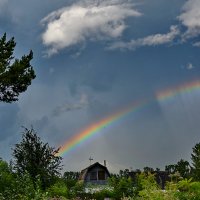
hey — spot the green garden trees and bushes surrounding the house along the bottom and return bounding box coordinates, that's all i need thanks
[0,128,200,200]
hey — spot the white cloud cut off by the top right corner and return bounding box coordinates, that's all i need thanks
[178,0,200,38]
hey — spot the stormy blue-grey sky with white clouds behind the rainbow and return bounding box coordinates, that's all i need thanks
[0,0,200,172]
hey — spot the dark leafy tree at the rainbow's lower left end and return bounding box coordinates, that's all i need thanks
[13,128,62,189]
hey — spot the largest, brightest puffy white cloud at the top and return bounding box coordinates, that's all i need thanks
[41,0,141,55]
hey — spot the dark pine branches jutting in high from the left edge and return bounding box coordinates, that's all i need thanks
[0,34,36,103]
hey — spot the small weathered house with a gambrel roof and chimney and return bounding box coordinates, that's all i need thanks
[79,161,110,185]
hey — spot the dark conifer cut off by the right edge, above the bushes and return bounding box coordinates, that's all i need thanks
[191,143,200,181]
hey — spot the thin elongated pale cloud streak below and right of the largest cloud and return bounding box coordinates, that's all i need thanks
[108,26,180,50]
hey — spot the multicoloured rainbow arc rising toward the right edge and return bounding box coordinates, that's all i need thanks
[57,80,200,156]
